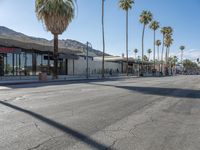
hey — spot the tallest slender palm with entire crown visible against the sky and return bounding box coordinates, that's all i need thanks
[140,10,152,74]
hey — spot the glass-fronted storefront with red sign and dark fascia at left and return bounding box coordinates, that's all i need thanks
[0,46,78,76]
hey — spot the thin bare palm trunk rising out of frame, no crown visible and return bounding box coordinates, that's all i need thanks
[102,0,105,78]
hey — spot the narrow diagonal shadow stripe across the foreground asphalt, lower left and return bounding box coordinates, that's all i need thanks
[0,101,111,150]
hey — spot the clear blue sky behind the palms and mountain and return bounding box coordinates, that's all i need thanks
[0,0,200,59]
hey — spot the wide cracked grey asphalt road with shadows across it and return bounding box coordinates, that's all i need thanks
[0,76,200,150]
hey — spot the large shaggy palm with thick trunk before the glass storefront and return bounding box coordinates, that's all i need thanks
[35,0,75,79]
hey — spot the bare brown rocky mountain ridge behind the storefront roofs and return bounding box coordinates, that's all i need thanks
[0,26,109,57]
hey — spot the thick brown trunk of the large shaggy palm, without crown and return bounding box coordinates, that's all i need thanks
[53,34,58,79]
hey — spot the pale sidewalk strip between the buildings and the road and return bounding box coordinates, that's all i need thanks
[0,75,136,86]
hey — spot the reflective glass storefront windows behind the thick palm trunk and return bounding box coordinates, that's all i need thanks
[0,50,68,76]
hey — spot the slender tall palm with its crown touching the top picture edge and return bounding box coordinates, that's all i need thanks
[119,0,134,76]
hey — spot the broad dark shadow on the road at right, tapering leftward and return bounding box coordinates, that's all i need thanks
[90,83,200,99]
